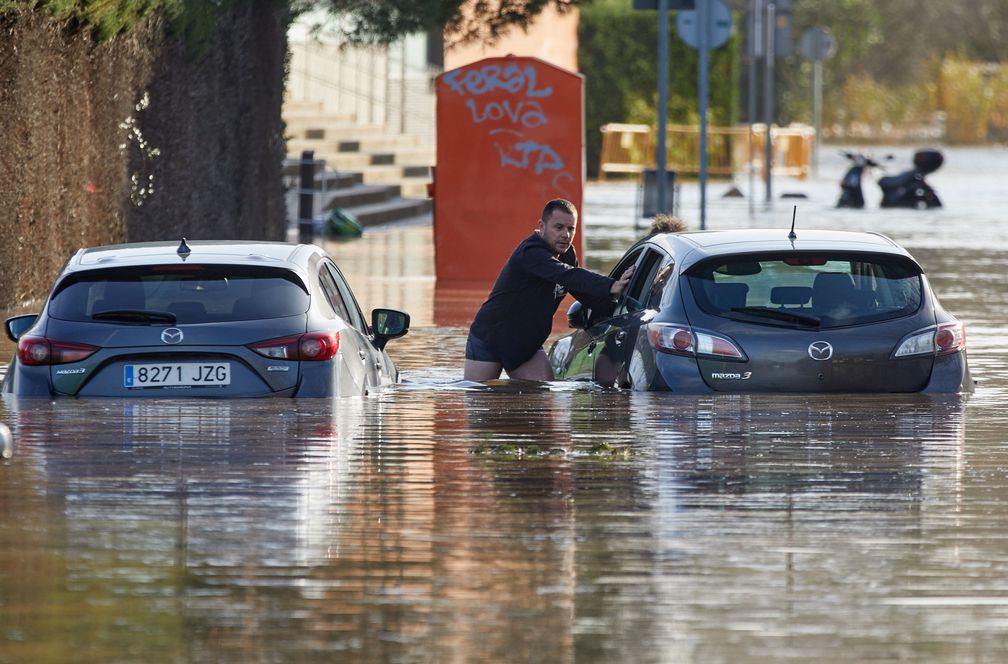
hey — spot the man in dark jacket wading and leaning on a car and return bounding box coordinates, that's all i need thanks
[464,198,633,382]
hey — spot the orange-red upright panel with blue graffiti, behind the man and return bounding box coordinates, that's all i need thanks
[433,56,585,283]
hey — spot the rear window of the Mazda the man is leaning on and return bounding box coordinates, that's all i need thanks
[688,252,922,328]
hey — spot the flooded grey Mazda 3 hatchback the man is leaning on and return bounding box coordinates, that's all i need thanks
[549,230,973,393]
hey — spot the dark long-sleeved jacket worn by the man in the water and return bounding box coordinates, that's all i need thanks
[469,233,613,371]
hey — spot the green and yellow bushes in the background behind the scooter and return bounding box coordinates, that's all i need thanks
[762,0,1008,143]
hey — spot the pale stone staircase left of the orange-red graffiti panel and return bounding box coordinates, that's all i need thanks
[283,102,434,226]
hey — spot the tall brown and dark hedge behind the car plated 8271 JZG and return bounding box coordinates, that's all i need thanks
[0,0,288,310]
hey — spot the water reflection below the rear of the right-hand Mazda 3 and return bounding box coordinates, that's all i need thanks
[628,395,966,511]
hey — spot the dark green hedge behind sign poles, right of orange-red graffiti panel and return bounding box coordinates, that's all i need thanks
[578,0,741,177]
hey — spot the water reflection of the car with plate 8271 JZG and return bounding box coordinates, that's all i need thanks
[0,395,385,575]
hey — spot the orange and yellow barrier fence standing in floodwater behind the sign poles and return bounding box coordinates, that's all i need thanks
[599,123,815,179]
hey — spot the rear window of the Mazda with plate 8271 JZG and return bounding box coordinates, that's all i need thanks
[48,265,308,324]
